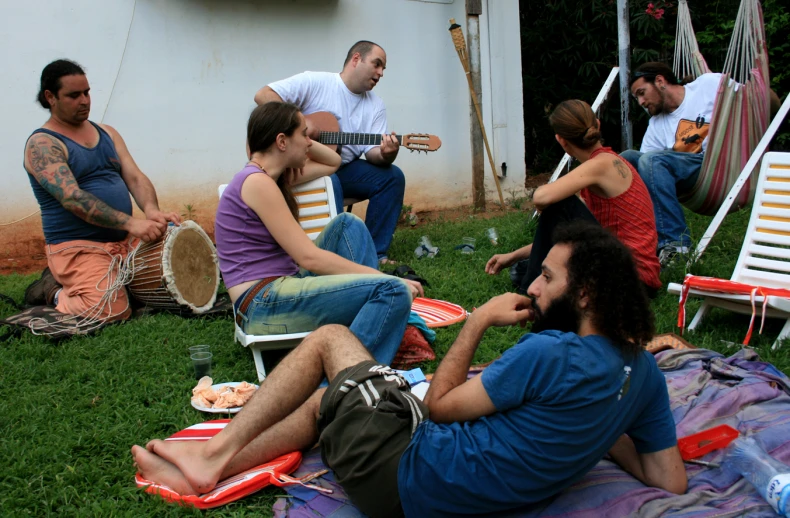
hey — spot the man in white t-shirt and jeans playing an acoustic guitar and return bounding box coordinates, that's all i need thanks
[255,40,406,263]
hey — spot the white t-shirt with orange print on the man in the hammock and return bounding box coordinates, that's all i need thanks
[640,74,721,153]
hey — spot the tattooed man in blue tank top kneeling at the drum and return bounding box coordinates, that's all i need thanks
[24,59,180,321]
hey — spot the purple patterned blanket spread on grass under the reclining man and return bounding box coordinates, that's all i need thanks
[274,349,790,518]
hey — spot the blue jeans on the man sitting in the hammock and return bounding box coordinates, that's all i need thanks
[620,149,704,250]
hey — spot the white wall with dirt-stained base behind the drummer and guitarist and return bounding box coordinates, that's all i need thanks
[0,0,524,260]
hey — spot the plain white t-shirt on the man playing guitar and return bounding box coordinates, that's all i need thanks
[268,71,387,164]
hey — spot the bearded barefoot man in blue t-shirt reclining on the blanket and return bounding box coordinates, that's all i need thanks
[132,223,686,517]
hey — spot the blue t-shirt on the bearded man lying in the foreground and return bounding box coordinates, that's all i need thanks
[398,331,677,517]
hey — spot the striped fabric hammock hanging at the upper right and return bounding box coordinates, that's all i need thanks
[674,0,770,215]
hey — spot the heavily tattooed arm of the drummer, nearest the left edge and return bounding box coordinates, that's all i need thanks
[25,133,162,241]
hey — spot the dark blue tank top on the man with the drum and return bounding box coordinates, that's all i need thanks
[27,122,132,245]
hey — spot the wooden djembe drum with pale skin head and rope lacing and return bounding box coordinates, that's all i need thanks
[129,221,220,313]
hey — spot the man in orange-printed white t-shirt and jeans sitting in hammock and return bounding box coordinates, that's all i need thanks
[621,62,721,267]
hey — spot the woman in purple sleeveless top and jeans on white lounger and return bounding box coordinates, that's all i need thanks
[215,102,422,370]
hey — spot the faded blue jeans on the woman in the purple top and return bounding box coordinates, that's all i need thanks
[239,213,411,365]
